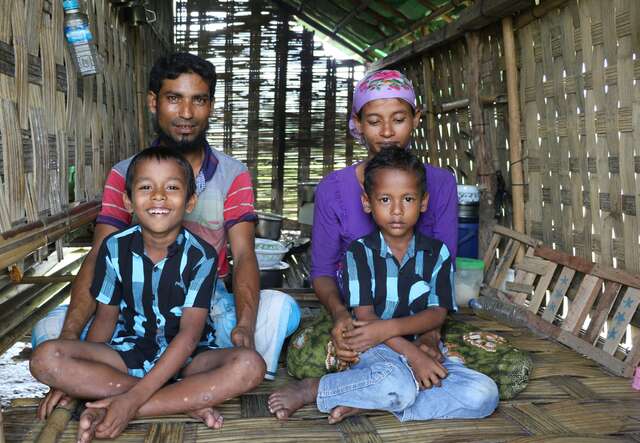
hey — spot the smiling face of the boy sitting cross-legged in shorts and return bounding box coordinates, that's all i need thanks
[124,159,196,235]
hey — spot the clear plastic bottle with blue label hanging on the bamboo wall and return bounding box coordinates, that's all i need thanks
[62,0,99,77]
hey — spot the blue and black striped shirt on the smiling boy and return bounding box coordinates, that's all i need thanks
[91,225,217,372]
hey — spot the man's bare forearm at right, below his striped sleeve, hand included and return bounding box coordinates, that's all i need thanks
[228,222,260,349]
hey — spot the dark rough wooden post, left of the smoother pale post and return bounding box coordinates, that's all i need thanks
[465,32,497,256]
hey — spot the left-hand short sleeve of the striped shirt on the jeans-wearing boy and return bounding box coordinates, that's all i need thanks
[341,241,375,308]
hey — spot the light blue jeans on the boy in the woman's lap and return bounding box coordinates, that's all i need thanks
[316,345,499,421]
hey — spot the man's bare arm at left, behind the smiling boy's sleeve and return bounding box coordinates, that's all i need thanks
[60,223,118,339]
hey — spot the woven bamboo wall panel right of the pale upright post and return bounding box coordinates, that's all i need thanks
[517,0,640,272]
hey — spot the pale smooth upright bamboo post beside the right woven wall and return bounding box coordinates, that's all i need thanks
[502,17,525,253]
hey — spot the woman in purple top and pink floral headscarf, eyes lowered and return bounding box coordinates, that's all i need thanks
[311,70,458,361]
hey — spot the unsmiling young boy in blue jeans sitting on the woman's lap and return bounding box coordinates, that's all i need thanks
[269,148,498,423]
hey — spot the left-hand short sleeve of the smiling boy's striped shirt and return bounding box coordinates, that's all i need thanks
[90,237,122,305]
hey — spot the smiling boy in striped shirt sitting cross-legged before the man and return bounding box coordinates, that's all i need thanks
[31,147,265,442]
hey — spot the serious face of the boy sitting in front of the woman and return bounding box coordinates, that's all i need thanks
[362,168,429,243]
